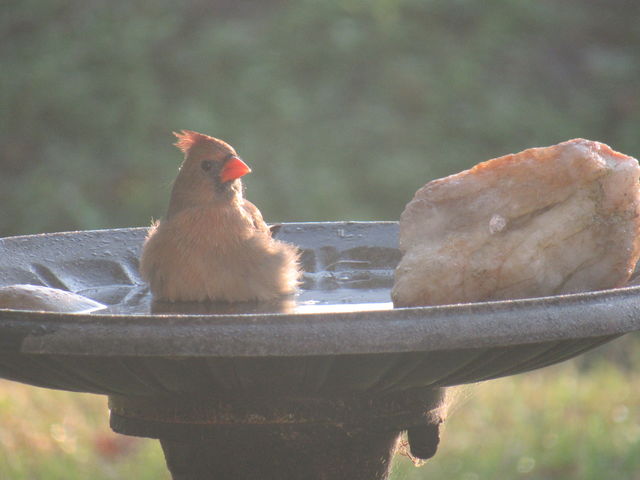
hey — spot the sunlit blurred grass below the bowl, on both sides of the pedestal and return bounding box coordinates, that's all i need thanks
[0,337,640,480]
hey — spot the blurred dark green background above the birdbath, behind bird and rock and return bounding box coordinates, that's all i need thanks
[0,0,640,235]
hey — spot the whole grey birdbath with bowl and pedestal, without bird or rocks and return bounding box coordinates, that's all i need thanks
[0,222,640,480]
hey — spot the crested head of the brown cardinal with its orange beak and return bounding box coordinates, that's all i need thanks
[168,130,251,216]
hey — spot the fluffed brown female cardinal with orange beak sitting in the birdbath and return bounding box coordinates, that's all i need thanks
[140,130,300,302]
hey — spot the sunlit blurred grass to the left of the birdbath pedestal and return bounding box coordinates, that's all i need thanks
[0,380,169,480]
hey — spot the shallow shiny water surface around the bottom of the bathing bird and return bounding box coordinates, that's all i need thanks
[81,285,393,315]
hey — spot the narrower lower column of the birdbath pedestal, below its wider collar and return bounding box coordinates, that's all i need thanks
[160,427,400,480]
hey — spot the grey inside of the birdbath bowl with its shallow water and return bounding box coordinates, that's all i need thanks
[0,222,400,315]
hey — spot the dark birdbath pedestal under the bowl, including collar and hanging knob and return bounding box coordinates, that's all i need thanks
[109,389,443,480]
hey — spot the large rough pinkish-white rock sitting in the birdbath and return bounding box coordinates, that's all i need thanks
[392,139,640,307]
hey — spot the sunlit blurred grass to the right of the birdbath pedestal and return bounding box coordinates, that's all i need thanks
[392,339,640,480]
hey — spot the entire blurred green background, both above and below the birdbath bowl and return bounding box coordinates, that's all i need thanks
[0,0,640,480]
